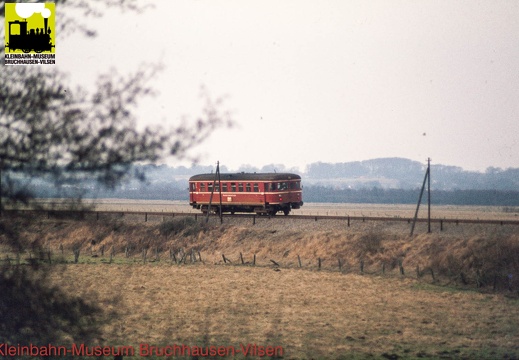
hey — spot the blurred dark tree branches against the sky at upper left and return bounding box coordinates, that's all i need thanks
[0,0,230,210]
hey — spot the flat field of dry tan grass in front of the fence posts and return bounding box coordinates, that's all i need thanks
[46,264,519,358]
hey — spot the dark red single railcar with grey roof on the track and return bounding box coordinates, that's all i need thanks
[189,173,303,215]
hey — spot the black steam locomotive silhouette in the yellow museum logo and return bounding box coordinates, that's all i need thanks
[6,18,54,53]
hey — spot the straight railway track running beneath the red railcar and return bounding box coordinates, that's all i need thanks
[2,209,519,225]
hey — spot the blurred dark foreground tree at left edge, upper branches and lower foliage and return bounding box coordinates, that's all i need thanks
[0,0,230,350]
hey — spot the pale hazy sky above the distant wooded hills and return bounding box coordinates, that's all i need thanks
[56,0,519,171]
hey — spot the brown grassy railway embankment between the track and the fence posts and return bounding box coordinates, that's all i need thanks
[0,217,519,294]
